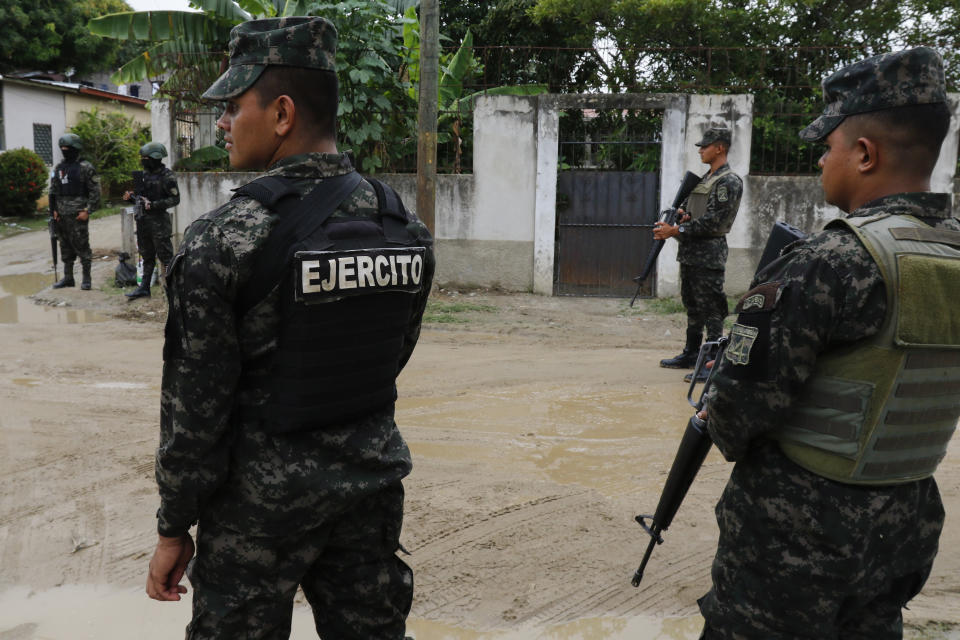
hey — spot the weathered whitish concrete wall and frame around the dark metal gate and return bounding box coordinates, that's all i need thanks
[163,94,960,296]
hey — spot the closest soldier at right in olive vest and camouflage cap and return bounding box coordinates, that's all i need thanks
[700,48,960,640]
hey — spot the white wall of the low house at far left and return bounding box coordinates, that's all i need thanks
[3,82,67,165]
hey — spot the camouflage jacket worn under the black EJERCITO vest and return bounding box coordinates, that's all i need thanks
[156,153,433,536]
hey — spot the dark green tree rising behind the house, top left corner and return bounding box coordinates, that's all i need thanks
[0,0,138,75]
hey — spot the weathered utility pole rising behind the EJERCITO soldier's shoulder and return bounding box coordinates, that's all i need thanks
[417,0,440,235]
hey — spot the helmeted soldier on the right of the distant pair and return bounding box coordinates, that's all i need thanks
[123,142,180,300]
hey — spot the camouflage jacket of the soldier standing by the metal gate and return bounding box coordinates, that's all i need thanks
[677,164,743,269]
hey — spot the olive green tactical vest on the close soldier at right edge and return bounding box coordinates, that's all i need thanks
[776,214,960,485]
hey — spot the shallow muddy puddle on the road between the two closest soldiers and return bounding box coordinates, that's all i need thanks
[397,386,692,494]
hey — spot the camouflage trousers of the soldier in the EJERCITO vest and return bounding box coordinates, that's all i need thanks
[186,482,413,640]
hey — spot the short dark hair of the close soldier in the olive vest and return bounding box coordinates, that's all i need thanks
[846,102,950,176]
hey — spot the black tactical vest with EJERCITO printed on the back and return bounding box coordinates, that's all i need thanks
[237,173,430,433]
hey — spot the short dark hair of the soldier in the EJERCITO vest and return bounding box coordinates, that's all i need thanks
[251,65,340,140]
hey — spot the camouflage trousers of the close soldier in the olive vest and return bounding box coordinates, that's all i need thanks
[699,441,944,640]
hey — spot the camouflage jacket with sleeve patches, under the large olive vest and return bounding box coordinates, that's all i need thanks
[707,193,960,460]
